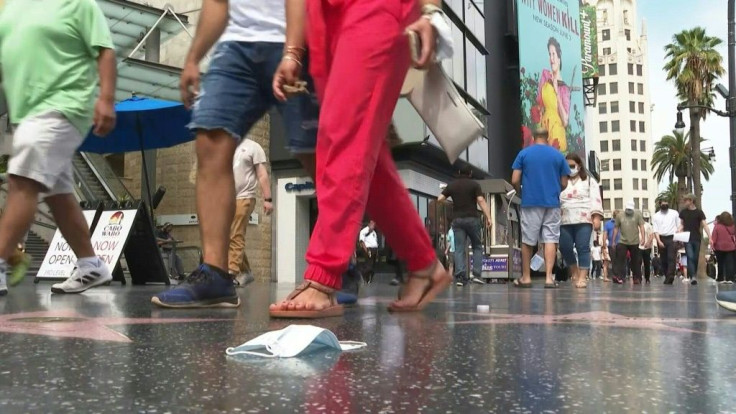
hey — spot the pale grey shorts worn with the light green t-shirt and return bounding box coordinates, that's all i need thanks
[8,111,84,197]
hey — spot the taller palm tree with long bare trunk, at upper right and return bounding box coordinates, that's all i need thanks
[664,27,725,205]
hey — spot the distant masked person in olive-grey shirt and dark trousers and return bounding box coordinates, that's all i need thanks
[613,201,644,285]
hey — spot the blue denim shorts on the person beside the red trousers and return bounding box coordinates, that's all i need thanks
[189,41,319,153]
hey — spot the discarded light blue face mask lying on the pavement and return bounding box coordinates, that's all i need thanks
[225,325,367,358]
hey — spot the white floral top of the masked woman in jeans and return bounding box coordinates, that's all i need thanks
[560,176,603,225]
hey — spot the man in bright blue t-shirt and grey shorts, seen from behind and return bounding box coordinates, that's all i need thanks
[511,130,571,288]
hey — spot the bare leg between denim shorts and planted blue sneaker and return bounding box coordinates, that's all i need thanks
[196,130,238,269]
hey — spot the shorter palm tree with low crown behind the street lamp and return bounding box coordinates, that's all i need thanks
[652,130,714,206]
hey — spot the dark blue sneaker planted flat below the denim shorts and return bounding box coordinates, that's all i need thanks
[151,264,240,308]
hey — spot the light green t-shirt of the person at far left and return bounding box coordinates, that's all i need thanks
[0,0,113,135]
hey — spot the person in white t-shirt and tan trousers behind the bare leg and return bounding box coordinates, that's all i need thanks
[227,138,273,287]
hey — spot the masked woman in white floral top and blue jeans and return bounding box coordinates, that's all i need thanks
[560,153,603,288]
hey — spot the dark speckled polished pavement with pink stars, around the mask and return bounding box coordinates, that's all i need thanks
[0,279,736,414]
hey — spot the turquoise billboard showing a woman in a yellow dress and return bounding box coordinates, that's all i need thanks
[517,0,586,159]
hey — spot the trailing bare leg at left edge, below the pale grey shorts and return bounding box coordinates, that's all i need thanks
[0,175,42,260]
